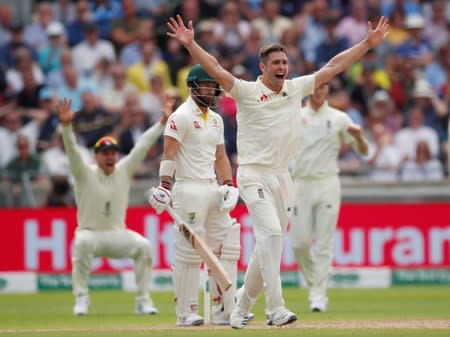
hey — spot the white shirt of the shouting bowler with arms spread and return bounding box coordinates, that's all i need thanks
[229,75,315,169]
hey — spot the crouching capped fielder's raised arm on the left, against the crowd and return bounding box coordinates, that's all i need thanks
[56,98,85,177]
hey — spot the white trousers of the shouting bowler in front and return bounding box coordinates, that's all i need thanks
[237,166,293,315]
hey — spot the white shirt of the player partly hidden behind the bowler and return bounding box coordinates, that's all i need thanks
[292,102,357,179]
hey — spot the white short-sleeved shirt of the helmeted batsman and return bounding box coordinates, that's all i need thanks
[164,97,224,181]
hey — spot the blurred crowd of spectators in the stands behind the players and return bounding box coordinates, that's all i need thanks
[0,0,450,206]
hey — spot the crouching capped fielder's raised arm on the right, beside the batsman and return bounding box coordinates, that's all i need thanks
[120,95,175,176]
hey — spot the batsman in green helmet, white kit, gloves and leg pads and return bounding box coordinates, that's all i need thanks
[149,65,240,326]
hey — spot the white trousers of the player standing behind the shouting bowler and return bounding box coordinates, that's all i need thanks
[290,176,341,301]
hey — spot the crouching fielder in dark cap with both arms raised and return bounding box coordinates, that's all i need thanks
[58,97,174,316]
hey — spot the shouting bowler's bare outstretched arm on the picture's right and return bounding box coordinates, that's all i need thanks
[315,16,389,88]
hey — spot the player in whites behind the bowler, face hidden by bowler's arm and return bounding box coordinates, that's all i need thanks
[290,84,368,312]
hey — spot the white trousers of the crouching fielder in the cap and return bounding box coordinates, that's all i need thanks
[72,229,152,302]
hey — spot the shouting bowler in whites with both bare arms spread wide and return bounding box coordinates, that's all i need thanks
[167,15,388,329]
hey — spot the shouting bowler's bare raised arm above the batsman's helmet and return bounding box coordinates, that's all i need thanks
[167,15,235,92]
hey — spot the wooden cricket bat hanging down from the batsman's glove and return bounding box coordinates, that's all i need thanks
[166,206,231,291]
